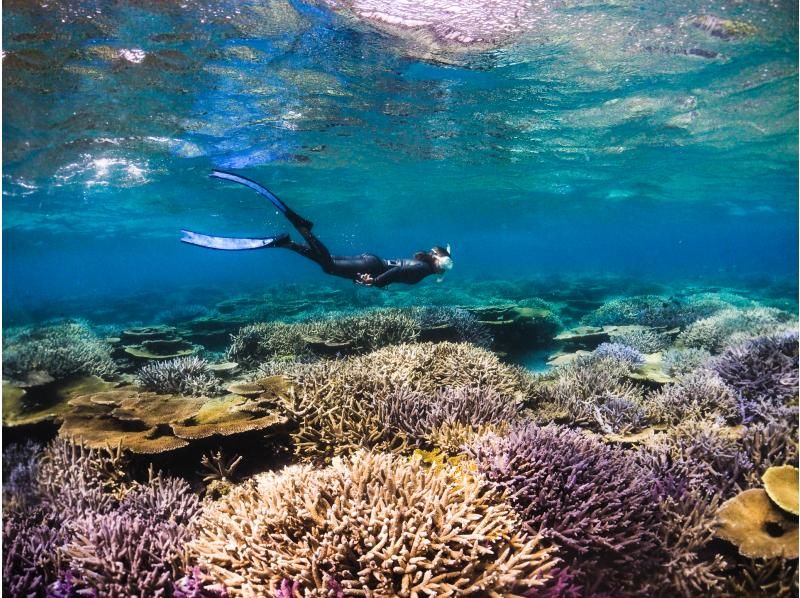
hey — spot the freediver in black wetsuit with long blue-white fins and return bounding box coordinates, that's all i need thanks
[181,170,453,288]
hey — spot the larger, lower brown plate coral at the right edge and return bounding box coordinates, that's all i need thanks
[717,488,798,559]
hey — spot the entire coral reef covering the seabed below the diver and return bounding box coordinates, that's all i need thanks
[3,282,798,598]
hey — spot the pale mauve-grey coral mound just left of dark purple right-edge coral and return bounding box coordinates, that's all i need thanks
[645,368,741,424]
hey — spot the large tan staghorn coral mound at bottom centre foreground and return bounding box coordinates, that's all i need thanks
[190,451,555,596]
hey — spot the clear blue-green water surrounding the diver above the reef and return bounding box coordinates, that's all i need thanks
[3,0,798,328]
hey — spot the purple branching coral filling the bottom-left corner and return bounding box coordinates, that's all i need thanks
[3,440,200,596]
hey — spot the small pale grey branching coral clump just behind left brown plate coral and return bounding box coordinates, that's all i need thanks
[136,357,223,397]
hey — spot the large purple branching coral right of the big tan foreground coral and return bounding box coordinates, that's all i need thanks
[469,424,664,595]
